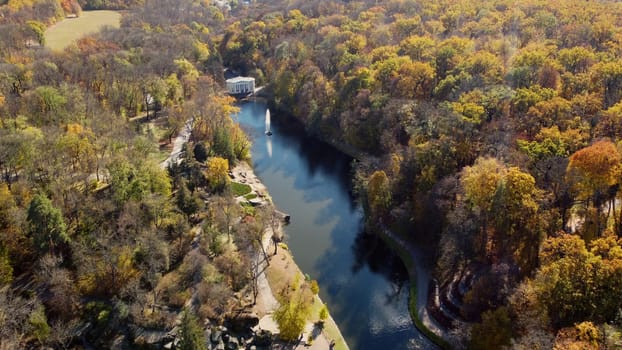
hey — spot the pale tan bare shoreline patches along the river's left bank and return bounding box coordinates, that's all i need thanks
[231,161,350,350]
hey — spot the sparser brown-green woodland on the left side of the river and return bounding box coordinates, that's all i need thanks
[0,0,292,349]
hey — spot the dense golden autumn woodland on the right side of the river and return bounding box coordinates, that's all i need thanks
[219,0,622,349]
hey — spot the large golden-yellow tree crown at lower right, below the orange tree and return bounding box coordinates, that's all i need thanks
[533,234,622,327]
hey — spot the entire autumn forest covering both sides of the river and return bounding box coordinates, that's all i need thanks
[0,0,622,349]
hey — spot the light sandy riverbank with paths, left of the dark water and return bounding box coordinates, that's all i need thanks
[231,162,349,350]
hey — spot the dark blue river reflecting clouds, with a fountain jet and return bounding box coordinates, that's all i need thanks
[234,102,435,350]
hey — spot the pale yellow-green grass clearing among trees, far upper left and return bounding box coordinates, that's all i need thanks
[45,11,121,51]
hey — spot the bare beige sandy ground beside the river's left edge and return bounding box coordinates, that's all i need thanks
[231,162,344,350]
